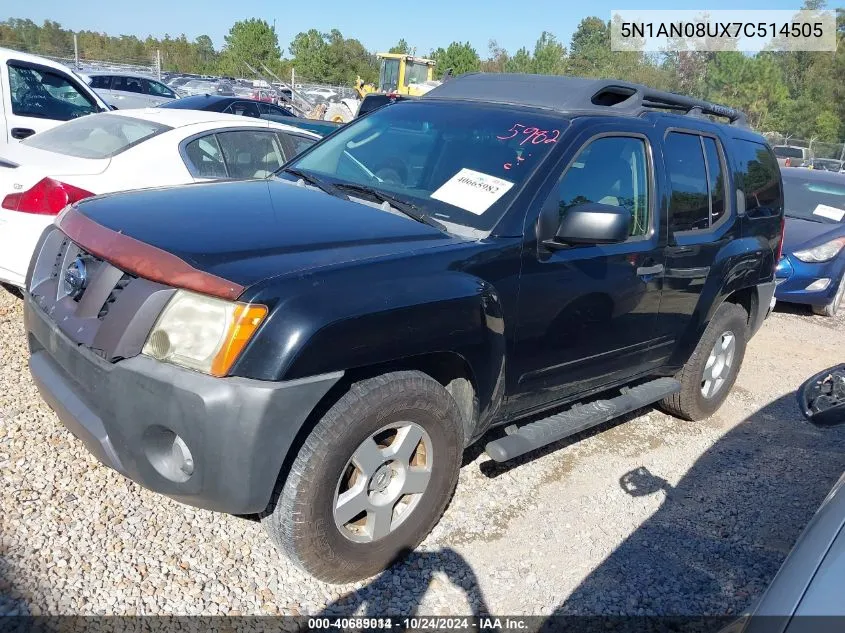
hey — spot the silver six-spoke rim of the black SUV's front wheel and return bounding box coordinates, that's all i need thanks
[332,422,434,543]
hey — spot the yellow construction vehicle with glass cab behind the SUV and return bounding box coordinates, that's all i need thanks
[323,53,440,123]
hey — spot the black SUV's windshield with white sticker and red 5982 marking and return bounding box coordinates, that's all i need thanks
[290,100,569,231]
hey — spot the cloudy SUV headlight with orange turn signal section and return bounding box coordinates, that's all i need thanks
[141,290,267,376]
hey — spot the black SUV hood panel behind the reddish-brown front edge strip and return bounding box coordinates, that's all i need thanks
[77,180,457,286]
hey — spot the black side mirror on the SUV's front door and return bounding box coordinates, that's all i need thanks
[547,202,631,244]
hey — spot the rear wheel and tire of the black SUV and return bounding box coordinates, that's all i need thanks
[659,302,748,420]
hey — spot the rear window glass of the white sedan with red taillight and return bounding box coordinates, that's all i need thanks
[21,114,172,158]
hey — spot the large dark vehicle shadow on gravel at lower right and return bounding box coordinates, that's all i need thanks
[547,393,845,629]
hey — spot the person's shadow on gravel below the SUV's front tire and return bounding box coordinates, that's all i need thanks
[318,547,489,631]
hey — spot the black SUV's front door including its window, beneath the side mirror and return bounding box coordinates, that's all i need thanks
[508,122,665,412]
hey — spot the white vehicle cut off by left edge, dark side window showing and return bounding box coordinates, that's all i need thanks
[0,48,109,148]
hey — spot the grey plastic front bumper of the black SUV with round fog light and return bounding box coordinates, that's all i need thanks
[24,297,343,514]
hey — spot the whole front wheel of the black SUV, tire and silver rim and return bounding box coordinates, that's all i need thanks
[262,371,463,583]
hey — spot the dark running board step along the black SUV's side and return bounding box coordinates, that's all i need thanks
[485,378,681,462]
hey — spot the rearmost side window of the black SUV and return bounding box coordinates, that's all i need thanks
[734,139,783,215]
